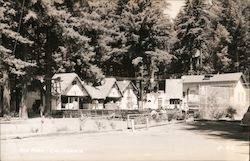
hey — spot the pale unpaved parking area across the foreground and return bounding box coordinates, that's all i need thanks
[1,123,249,161]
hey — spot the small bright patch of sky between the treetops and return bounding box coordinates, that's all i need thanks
[165,0,185,19]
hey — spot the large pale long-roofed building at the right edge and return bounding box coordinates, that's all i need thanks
[181,73,249,117]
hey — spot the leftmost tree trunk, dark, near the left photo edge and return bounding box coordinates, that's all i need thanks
[3,70,10,116]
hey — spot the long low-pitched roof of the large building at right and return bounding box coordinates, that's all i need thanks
[181,73,243,83]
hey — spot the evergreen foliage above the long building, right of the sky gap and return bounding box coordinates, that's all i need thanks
[170,0,250,75]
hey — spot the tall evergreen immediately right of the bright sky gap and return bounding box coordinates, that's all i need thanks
[173,0,217,74]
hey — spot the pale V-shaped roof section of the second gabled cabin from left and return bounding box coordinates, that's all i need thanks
[83,78,119,99]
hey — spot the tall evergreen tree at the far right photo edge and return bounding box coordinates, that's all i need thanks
[220,0,250,80]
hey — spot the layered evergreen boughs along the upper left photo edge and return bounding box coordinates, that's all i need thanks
[0,1,35,76]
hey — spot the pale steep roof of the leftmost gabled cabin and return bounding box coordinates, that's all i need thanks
[52,73,81,93]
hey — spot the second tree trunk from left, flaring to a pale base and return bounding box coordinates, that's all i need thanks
[19,83,28,119]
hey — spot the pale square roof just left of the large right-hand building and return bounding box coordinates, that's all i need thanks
[165,79,183,99]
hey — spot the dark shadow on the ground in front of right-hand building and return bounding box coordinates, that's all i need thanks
[184,120,250,141]
